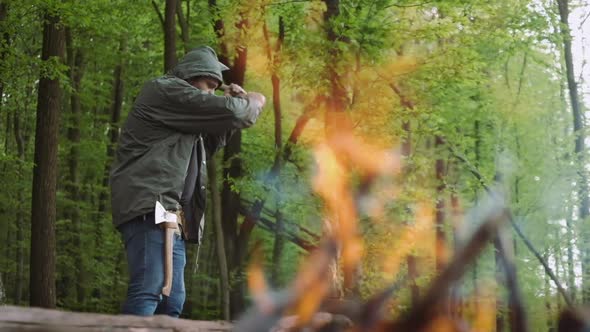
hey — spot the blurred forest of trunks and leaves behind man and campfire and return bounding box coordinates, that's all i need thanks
[0,0,590,331]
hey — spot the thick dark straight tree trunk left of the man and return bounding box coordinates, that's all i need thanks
[30,14,64,308]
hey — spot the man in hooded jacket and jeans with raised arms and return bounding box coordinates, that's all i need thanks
[110,46,266,317]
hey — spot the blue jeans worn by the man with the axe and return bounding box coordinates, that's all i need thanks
[118,213,186,317]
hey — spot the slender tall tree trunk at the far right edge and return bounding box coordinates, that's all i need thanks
[557,0,590,304]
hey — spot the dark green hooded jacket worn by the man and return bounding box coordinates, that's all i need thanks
[110,47,261,242]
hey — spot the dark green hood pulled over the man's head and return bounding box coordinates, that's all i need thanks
[171,46,229,85]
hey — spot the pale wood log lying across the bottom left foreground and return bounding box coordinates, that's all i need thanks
[0,306,232,332]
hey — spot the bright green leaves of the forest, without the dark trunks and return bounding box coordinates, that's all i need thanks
[0,0,583,331]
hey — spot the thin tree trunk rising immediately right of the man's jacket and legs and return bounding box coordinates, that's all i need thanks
[207,158,230,321]
